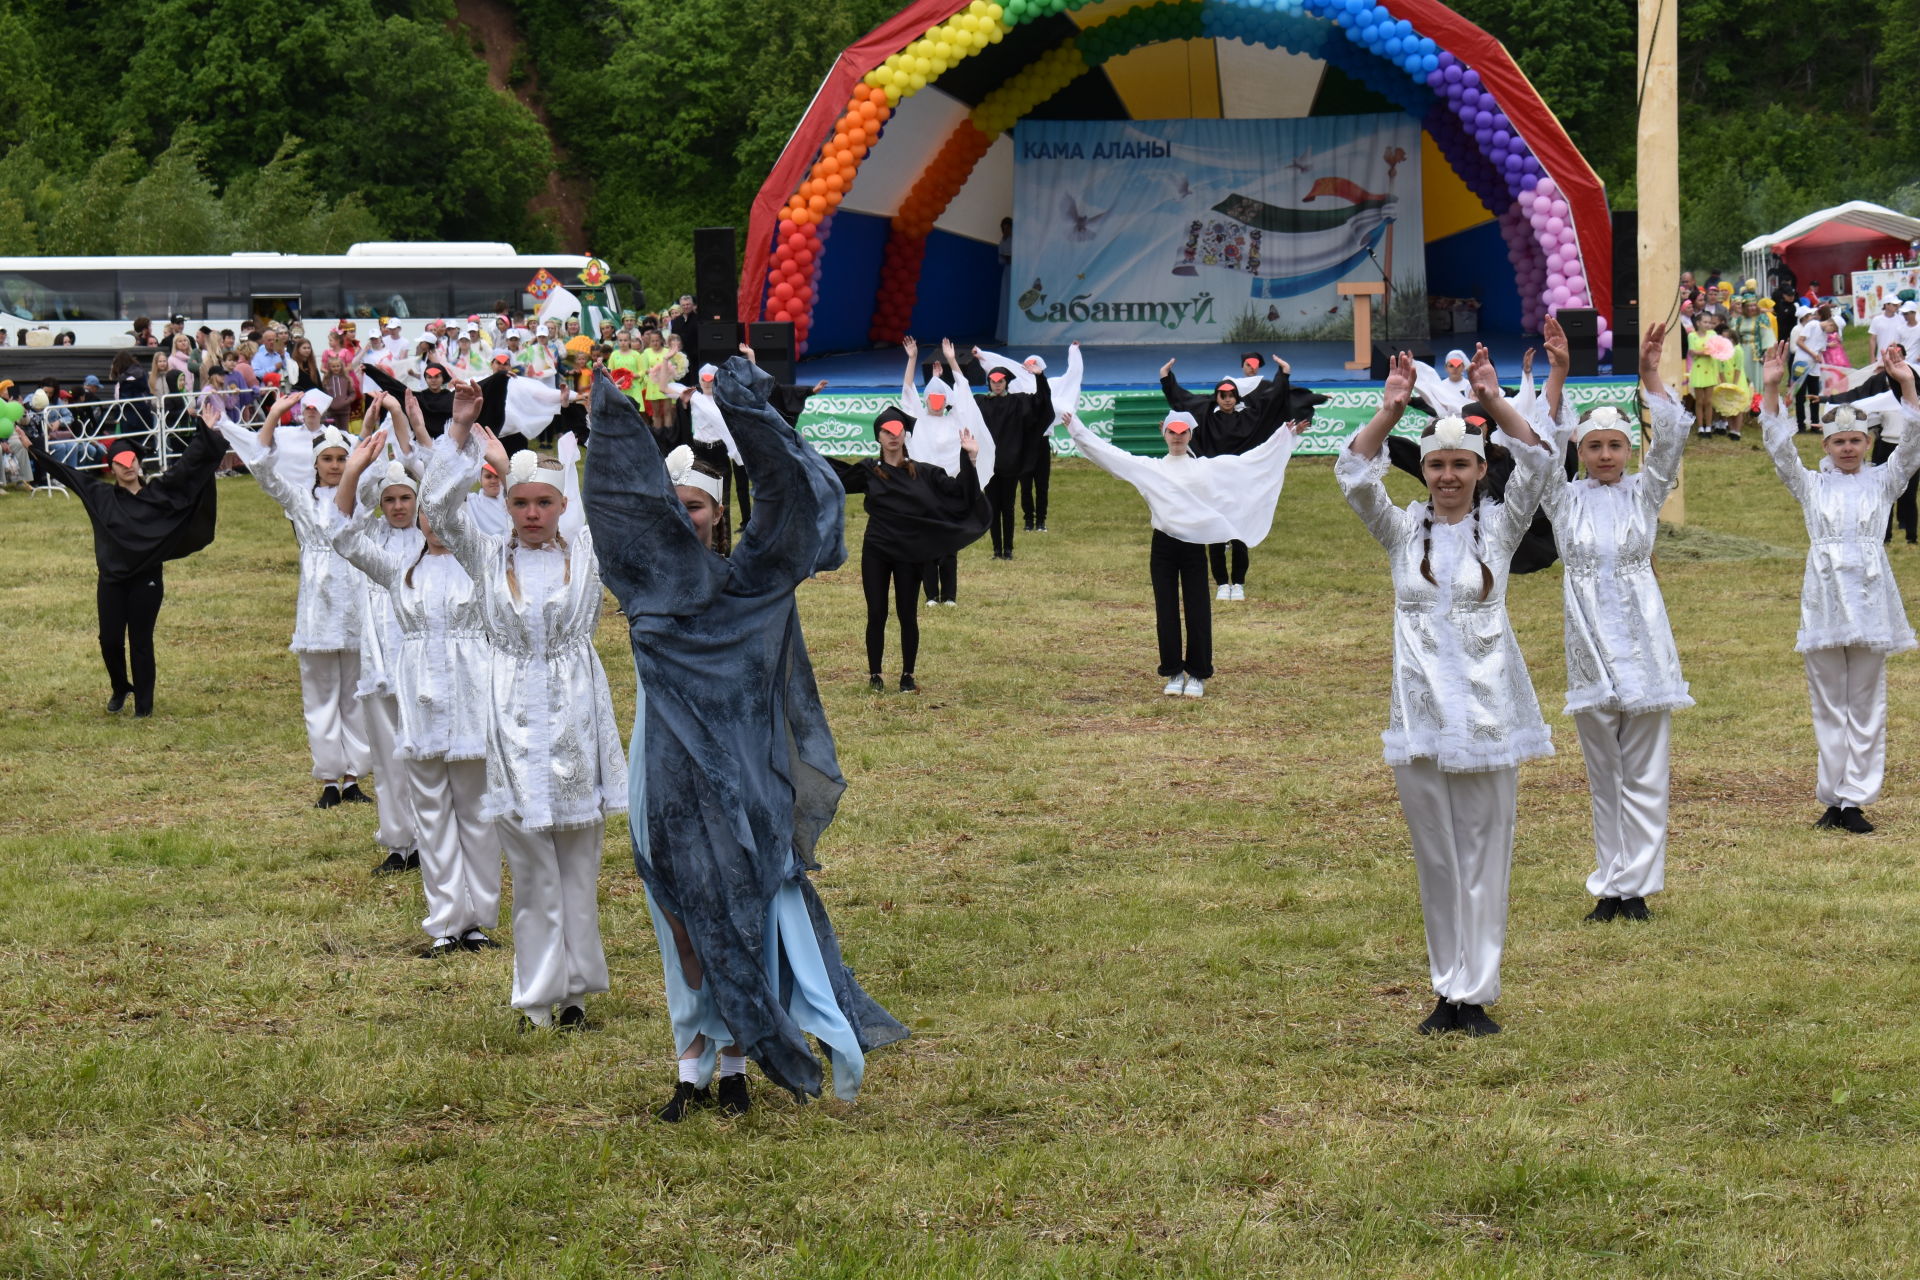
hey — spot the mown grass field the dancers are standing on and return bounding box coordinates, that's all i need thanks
[0,432,1920,1278]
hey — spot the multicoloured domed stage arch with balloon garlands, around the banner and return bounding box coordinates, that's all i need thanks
[739,0,1613,351]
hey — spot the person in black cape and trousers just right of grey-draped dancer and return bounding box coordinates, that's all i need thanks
[833,407,991,693]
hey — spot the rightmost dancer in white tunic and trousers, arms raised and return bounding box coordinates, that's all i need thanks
[1761,344,1920,835]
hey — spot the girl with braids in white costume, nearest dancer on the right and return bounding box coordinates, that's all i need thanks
[1334,347,1555,1036]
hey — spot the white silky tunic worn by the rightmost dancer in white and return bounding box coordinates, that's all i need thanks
[1761,407,1920,652]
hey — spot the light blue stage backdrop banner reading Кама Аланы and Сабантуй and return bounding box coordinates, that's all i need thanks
[1010,113,1427,345]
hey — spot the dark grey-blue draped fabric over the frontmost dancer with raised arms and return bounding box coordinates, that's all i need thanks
[584,357,906,1096]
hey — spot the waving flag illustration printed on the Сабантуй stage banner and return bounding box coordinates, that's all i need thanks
[1173,178,1398,297]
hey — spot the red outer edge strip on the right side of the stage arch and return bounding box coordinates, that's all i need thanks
[1379,0,1613,328]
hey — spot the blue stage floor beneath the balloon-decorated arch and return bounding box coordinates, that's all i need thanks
[797,334,1605,391]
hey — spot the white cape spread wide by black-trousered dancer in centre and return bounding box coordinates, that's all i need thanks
[1068,418,1300,547]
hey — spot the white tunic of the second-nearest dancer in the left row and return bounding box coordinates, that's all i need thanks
[334,510,492,760]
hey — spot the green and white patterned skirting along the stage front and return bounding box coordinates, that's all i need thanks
[801,378,1640,459]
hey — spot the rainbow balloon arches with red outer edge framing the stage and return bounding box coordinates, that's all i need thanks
[739,0,1613,362]
